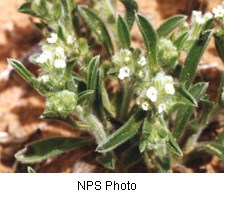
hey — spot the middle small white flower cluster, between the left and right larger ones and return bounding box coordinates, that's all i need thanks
[112,49,147,80]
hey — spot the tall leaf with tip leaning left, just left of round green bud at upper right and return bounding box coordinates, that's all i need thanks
[136,14,158,72]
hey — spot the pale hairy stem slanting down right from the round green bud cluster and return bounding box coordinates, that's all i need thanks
[75,106,107,144]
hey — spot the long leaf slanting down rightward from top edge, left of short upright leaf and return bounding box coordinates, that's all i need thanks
[78,6,113,55]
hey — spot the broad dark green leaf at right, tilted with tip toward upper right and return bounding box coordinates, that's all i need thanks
[180,31,212,88]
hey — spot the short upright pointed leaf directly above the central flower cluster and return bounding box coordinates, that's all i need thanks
[117,15,131,49]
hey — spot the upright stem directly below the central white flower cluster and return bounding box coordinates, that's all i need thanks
[118,83,133,121]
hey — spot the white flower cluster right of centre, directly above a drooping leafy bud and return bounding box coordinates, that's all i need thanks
[137,72,175,114]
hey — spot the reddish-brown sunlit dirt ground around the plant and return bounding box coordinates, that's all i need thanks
[0,0,223,172]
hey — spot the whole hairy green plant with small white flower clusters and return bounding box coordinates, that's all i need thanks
[9,0,224,172]
